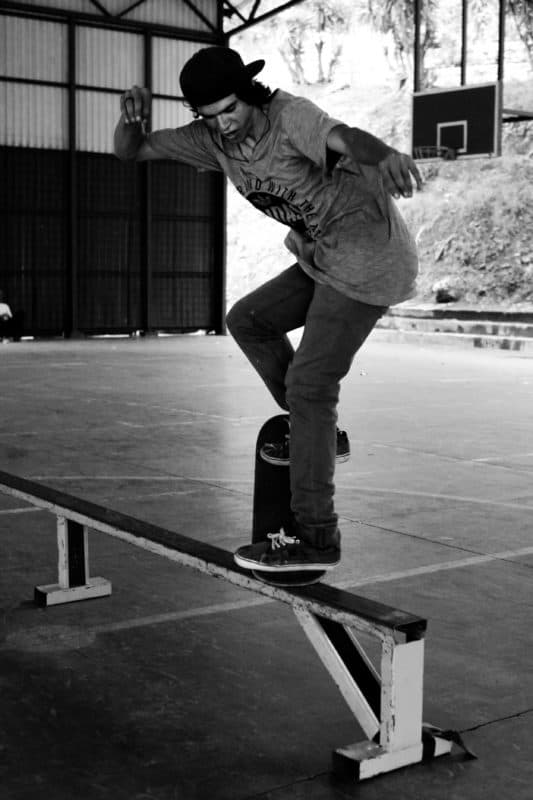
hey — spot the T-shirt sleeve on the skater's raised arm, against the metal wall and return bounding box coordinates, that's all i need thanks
[147,120,222,171]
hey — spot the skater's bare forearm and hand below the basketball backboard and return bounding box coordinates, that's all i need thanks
[327,125,422,198]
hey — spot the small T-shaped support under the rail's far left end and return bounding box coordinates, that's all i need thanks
[34,516,111,606]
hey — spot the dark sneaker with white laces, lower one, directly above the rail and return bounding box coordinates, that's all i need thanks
[234,531,341,572]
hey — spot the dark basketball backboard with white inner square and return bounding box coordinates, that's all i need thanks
[412,82,502,160]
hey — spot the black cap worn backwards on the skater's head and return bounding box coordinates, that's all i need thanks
[180,47,265,108]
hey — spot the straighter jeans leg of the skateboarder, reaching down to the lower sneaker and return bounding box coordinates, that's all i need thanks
[286,284,386,547]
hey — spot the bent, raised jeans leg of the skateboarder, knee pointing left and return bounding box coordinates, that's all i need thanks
[226,264,315,411]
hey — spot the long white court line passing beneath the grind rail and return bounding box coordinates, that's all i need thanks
[84,547,533,633]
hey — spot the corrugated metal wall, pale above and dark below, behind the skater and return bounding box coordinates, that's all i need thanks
[0,0,224,335]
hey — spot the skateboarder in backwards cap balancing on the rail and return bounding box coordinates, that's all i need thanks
[115,47,421,573]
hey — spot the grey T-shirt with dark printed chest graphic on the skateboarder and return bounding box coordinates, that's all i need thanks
[148,90,418,306]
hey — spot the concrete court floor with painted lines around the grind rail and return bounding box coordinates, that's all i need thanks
[0,336,533,800]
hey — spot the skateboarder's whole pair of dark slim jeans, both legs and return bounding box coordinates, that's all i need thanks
[227,264,387,548]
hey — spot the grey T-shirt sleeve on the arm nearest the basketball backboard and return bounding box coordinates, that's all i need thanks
[282,97,341,169]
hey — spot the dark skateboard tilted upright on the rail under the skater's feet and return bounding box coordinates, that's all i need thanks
[252,414,326,587]
